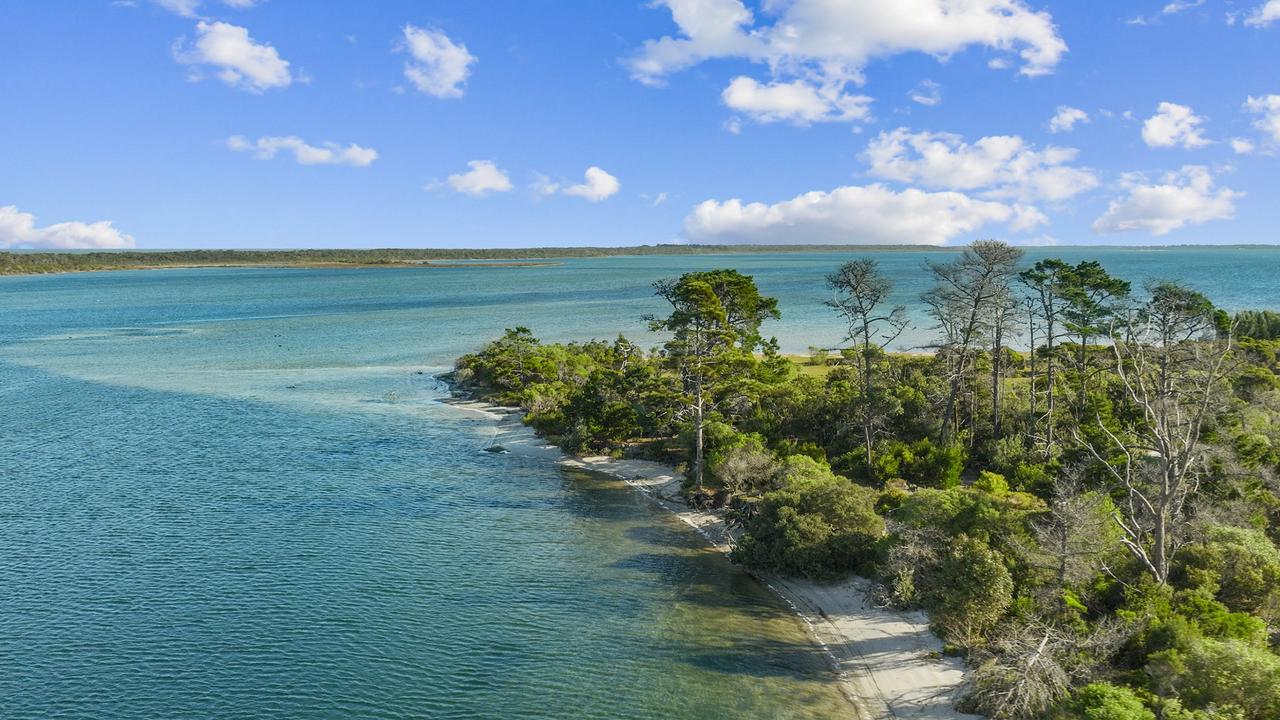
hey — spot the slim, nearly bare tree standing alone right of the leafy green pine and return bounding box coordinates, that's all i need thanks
[827,258,909,480]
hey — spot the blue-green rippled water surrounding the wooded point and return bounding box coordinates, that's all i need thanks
[0,249,1280,719]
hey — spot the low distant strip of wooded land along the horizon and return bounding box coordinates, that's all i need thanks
[0,245,947,275]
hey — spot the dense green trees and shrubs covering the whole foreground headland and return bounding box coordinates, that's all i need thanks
[454,241,1280,720]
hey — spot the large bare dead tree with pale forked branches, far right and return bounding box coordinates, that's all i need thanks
[1076,283,1231,584]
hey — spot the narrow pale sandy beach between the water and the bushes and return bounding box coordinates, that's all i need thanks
[440,397,979,720]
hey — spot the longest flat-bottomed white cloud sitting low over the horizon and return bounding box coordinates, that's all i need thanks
[685,184,1046,245]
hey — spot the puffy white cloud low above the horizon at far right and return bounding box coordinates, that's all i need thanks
[1093,165,1244,237]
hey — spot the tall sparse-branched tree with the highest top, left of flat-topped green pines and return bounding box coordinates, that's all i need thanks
[923,240,1023,441]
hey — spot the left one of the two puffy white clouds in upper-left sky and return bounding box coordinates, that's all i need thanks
[174,20,293,92]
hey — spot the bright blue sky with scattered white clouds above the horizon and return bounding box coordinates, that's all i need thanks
[0,0,1280,250]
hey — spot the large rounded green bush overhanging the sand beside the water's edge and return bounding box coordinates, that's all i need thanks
[733,456,884,579]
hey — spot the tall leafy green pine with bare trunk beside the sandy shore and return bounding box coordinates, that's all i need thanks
[648,270,780,491]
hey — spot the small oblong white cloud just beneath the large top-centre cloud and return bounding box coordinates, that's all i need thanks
[721,76,872,126]
